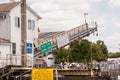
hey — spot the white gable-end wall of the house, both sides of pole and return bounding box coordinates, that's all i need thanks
[10,5,38,54]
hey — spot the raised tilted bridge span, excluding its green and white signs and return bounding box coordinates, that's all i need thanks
[34,22,97,59]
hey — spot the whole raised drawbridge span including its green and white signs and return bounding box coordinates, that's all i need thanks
[34,22,97,59]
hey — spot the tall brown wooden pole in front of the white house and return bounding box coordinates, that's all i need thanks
[21,0,27,66]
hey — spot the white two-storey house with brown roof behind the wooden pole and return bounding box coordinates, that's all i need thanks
[0,1,41,67]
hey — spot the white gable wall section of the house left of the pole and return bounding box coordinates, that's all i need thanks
[10,5,21,54]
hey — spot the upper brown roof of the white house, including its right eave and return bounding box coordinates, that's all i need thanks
[0,2,41,19]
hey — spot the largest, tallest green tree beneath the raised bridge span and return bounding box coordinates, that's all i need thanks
[70,39,90,63]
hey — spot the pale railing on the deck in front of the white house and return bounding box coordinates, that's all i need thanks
[0,54,33,68]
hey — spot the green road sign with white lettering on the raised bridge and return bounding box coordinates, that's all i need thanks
[40,41,52,54]
